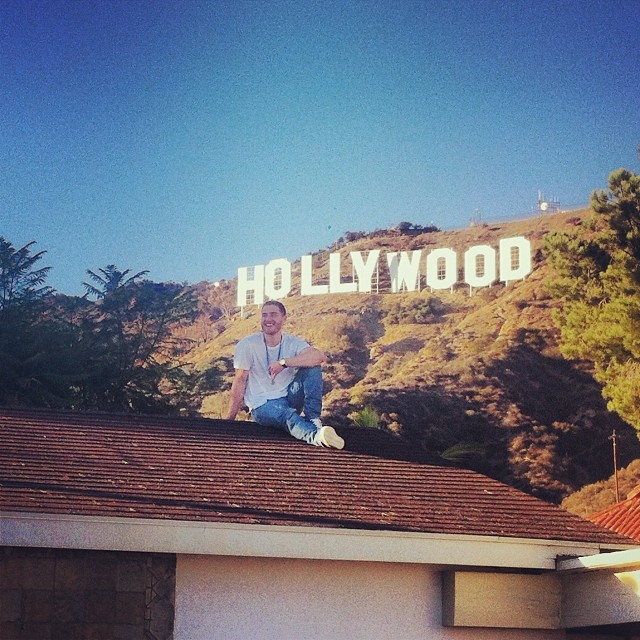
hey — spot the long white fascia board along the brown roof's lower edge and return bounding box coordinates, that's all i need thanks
[0,511,628,570]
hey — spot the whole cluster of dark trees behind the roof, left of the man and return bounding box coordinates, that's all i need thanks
[0,237,220,413]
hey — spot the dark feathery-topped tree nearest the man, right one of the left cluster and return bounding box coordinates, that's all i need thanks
[78,265,208,411]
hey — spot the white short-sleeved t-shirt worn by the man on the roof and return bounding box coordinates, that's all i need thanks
[233,332,310,410]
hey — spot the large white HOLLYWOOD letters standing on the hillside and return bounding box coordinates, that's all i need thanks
[237,236,531,307]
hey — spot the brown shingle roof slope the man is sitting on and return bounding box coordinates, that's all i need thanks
[0,410,629,545]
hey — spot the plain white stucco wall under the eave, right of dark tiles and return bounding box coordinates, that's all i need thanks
[175,555,565,640]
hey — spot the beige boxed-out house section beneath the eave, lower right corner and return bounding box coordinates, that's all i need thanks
[442,548,640,637]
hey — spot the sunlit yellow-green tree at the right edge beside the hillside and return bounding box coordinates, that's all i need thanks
[545,169,640,431]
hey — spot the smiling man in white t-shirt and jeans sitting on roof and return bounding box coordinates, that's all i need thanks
[227,300,344,449]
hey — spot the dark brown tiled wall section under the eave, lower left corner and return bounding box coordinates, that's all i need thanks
[0,547,176,640]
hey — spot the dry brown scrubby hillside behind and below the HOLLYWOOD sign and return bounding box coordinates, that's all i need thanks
[184,210,640,502]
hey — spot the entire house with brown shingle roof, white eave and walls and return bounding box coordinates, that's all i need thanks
[0,409,640,640]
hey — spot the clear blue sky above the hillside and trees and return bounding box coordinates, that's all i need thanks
[0,0,640,293]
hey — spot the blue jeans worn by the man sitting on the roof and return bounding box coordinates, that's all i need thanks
[251,366,322,444]
